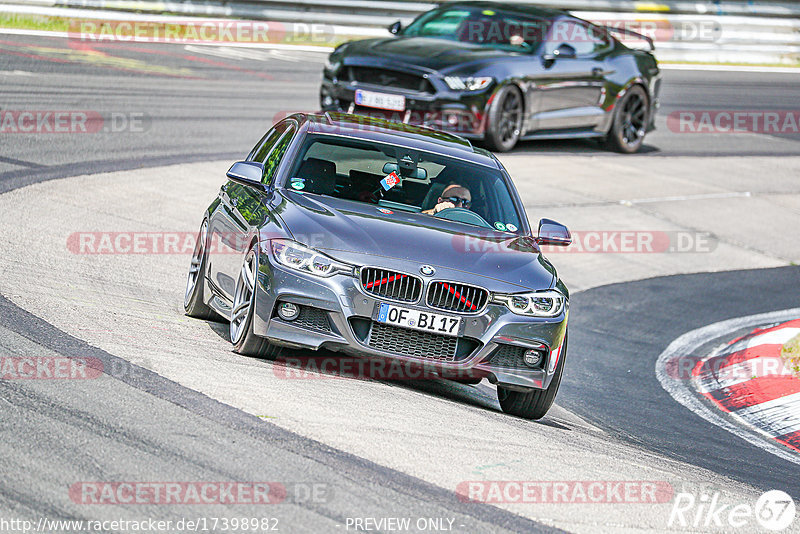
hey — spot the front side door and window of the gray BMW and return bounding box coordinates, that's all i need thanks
[208,122,297,304]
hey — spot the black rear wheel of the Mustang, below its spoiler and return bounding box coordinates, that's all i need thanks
[602,85,650,154]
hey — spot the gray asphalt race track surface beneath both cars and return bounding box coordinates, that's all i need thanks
[0,33,800,533]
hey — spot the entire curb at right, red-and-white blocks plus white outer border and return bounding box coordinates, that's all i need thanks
[655,308,800,464]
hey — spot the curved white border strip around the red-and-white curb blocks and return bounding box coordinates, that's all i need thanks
[656,308,800,465]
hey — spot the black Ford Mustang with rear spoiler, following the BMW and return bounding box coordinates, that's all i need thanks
[320,2,660,153]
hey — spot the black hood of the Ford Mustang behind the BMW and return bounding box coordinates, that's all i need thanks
[344,37,511,71]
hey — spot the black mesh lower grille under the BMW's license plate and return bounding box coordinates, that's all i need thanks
[366,321,479,362]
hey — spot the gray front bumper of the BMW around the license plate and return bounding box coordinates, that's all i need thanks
[253,252,568,390]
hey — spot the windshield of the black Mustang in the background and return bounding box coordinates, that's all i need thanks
[402,6,548,51]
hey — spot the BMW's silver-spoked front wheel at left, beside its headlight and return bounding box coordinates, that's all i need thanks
[230,244,282,360]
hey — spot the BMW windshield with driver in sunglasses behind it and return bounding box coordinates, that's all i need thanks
[285,134,522,232]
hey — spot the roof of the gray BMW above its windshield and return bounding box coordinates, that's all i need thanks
[298,112,499,168]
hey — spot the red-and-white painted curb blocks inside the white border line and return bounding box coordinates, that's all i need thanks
[692,319,800,451]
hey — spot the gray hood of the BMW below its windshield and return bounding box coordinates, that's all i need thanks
[275,190,555,289]
